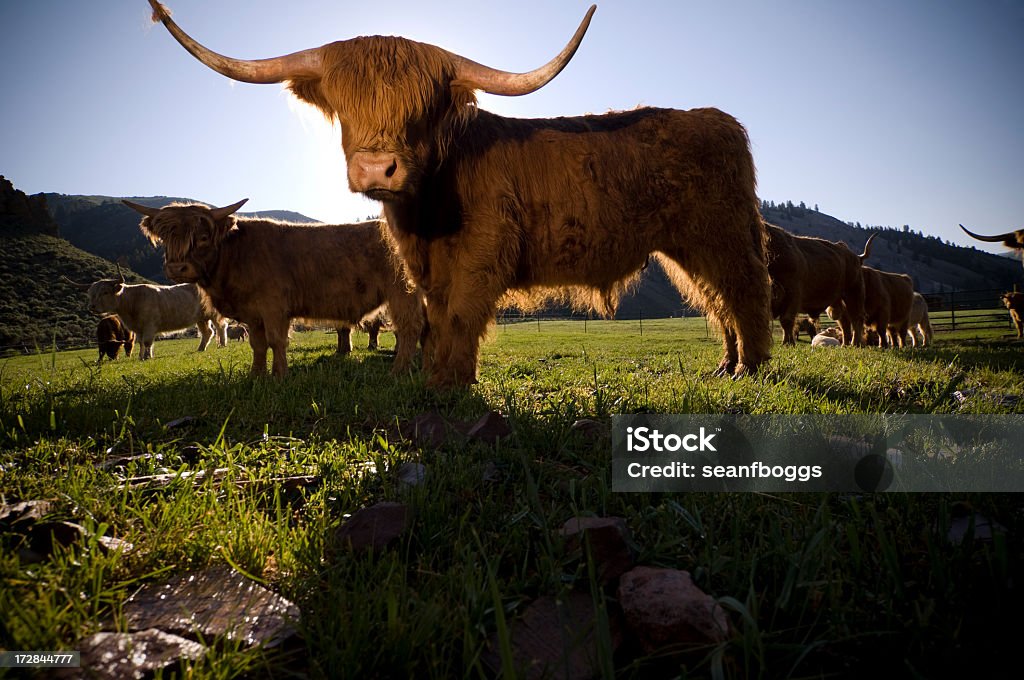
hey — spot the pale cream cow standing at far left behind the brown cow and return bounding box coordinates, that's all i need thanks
[68,267,227,360]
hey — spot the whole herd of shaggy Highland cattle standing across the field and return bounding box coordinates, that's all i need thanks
[66,0,1024,387]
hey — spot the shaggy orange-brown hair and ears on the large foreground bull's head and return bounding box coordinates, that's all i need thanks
[288,36,477,161]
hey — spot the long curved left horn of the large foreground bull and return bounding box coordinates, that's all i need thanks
[150,0,323,85]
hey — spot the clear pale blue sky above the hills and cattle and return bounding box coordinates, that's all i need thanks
[0,0,1024,252]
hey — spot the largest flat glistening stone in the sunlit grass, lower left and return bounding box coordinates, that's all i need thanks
[124,566,299,647]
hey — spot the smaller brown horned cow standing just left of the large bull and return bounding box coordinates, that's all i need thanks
[129,201,424,377]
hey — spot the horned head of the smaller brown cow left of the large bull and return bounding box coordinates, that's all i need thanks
[124,199,248,286]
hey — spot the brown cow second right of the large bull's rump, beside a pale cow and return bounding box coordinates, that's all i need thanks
[828,266,913,347]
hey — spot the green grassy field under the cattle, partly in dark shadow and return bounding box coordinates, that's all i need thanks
[0,318,1024,678]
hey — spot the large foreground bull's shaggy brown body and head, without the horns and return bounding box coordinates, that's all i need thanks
[154,2,771,386]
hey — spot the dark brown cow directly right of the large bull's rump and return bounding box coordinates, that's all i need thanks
[768,224,873,345]
